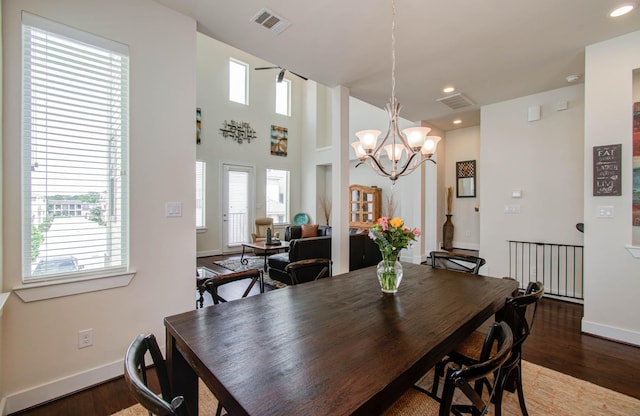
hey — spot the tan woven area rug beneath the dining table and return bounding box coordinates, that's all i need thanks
[114,361,640,416]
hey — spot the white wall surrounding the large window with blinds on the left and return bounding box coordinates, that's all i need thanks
[1,0,196,412]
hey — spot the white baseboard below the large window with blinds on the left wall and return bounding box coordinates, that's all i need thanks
[0,359,124,415]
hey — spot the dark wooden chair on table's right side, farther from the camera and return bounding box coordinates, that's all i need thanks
[432,282,544,416]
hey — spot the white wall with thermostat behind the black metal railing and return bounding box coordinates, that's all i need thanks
[478,84,584,277]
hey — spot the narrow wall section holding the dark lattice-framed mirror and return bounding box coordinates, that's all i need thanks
[440,126,482,250]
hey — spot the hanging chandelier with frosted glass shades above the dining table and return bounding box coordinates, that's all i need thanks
[351,0,441,183]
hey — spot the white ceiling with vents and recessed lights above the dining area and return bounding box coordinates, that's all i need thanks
[151,0,640,130]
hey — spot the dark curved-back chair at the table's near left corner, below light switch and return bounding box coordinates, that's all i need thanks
[124,334,189,416]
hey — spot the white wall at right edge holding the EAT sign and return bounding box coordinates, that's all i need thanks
[582,31,640,345]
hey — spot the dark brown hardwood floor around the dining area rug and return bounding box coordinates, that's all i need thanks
[13,260,640,416]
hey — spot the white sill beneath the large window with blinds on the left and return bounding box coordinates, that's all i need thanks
[13,271,136,302]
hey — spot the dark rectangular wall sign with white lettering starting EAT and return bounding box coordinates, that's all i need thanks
[593,144,622,196]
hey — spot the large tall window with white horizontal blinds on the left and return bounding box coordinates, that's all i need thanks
[22,12,129,281]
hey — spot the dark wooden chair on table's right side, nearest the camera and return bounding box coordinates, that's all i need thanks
[383,322,513,416]
